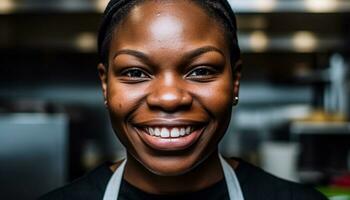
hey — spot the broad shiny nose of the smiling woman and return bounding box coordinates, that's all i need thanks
[147,76,193,112]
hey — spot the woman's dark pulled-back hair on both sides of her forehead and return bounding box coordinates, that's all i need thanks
[98,0,240,70]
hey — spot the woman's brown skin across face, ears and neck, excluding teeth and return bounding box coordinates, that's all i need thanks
[98,1,240,194]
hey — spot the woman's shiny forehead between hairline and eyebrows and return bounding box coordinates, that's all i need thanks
[111,0,227,55]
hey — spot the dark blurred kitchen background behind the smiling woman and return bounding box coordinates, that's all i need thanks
[0,0,350,199]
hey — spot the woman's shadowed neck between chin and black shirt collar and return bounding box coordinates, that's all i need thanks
[124,151,223,194]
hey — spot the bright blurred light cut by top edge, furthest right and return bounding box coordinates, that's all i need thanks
[305,0,338,12]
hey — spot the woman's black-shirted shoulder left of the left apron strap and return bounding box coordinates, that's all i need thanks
[39,163,113,200]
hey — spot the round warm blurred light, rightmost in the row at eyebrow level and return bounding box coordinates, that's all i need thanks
[292,31,317,52]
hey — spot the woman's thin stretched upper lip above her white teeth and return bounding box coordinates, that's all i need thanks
[133,118,206,127]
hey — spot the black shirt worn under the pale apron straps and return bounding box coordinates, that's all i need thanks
[40,160,327,200]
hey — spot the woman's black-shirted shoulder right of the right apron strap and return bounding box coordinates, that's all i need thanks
[235,159,327,200]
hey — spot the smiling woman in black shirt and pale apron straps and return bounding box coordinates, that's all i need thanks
[43,0,326,200]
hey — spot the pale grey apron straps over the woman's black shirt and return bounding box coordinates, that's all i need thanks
[103,154,244,200]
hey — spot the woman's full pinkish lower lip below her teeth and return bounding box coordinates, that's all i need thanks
[138,127,204,151]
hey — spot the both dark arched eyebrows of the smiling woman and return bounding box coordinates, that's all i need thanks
[113,46,225,62]
